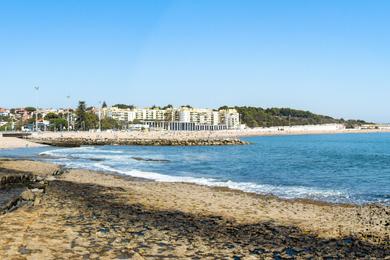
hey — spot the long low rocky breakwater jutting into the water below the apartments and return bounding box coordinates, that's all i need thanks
[26,138,249,147]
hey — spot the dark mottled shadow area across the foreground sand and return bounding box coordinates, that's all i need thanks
[42,180,390,259]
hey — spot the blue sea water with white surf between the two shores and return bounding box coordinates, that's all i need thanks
[0,133,390,205]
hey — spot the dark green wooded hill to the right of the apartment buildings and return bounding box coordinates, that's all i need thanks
[219,106,368,128]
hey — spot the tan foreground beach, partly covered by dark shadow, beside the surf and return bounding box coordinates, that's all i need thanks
[0,160,390,259]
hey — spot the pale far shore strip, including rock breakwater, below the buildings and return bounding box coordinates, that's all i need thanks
[0,127,390,149]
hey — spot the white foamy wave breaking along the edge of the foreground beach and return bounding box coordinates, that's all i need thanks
[40,146,390,204]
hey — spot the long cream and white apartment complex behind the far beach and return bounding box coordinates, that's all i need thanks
[102,107,240,131]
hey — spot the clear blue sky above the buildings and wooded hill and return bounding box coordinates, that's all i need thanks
[0,0,390,122]
